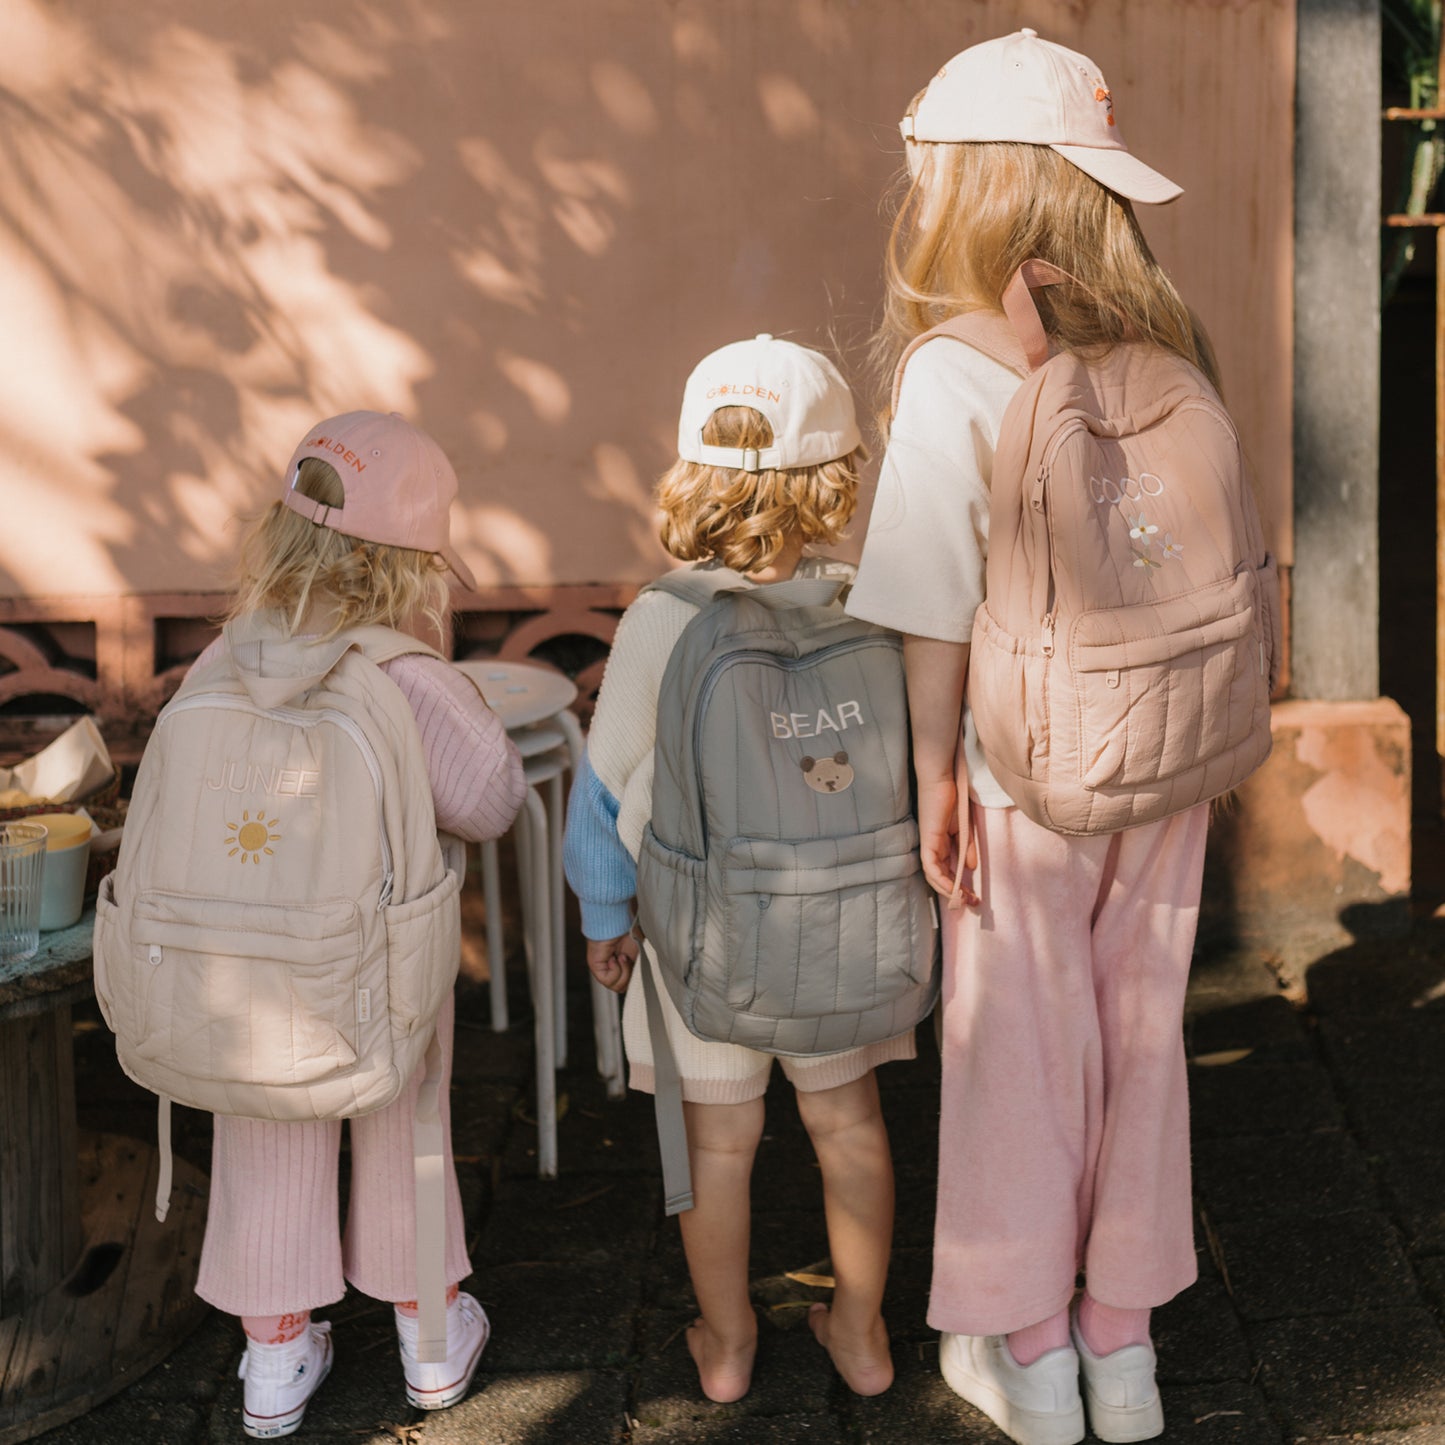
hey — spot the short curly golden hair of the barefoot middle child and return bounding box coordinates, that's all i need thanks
[657,406,867,572]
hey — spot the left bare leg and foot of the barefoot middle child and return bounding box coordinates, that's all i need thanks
[678,1098,763,1403]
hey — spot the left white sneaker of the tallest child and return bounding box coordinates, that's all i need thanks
[938,1334,1084,1445]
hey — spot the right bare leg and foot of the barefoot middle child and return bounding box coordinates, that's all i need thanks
[798,1071,893,1394]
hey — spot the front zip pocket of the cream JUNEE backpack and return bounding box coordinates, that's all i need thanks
[131,893,361,1103]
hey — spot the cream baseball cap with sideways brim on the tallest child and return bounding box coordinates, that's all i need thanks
[900,30,1183,202]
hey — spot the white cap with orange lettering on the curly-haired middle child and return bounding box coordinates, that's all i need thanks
[678,331,863,471]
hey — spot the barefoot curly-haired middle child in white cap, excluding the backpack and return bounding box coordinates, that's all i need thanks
[566,335,915,1400]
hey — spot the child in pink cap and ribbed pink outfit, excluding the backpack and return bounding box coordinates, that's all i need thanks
[177,412,525,1439]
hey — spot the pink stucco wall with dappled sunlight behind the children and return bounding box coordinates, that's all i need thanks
[0,0,1293,598]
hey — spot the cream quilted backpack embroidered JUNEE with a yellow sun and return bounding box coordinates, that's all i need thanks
[94,614,464,1358]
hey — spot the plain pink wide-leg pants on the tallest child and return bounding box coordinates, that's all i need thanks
[928,803,1209,1335]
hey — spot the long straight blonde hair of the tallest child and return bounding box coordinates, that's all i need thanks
[874,130,1221,390]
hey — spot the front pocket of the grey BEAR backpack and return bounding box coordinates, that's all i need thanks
[723,818,933,1023]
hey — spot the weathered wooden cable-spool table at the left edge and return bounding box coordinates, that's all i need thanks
[0,913,207,1445]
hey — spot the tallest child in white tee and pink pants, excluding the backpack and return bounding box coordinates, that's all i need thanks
[848,29,1217,1445]
